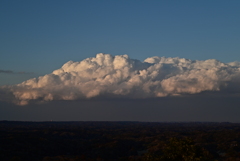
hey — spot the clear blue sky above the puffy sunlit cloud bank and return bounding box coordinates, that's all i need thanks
[0,0,240,85]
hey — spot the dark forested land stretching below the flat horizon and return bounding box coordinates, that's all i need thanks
[0,121,240,161]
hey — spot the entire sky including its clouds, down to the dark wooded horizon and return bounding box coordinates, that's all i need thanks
[0,0,240,122]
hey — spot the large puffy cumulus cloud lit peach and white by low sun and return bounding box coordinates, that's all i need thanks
[1,53,240,105]
